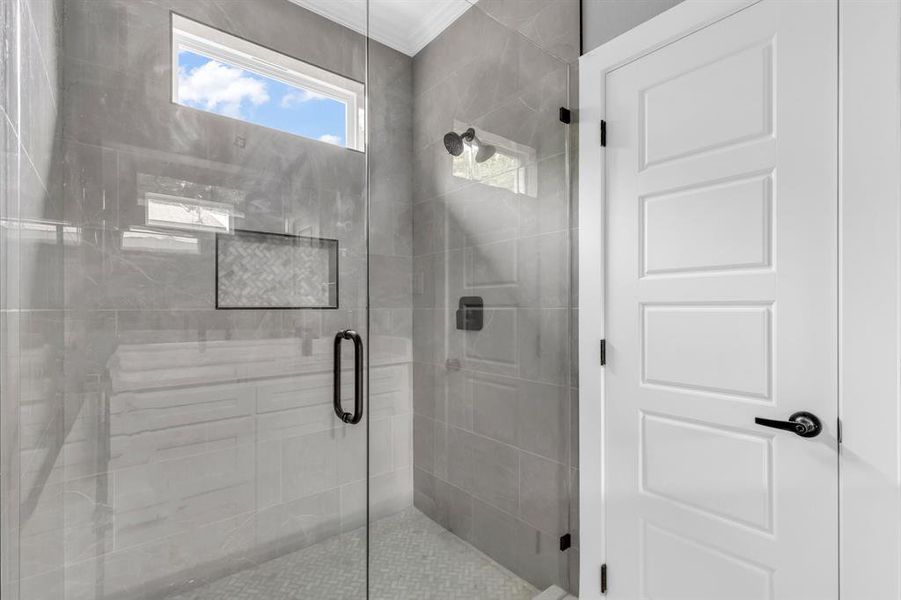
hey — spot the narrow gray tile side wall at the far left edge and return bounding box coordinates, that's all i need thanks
[0,0,65,598]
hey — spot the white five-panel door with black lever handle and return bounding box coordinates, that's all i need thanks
[605,0,838,600]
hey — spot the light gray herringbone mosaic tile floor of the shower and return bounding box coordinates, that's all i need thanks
[169,509,538,600]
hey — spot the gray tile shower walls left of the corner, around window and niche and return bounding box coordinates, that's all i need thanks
[0,0,413,600]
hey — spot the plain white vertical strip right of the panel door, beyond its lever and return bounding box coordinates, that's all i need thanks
[839,0,901,600]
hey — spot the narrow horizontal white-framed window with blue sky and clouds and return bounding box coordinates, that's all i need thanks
[172,14,365,150]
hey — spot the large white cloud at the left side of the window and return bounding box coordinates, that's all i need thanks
[178,60,269,118]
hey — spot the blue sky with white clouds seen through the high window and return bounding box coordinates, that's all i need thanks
[178,50,346,146]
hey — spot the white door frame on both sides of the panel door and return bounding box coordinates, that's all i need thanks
[578,0,901,600]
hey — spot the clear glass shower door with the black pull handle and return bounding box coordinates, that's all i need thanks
[0,0,370,600]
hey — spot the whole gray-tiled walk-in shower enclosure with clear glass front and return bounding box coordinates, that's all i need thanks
[0,0,579,600]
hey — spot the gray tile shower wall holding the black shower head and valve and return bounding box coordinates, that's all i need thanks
[412,0,579,590]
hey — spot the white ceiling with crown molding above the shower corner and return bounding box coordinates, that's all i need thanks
[291,0,472,56]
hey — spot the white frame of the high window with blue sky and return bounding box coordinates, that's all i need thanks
[172,13,366,152]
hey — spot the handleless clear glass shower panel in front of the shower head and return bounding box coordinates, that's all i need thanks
[370,0,578,600]
